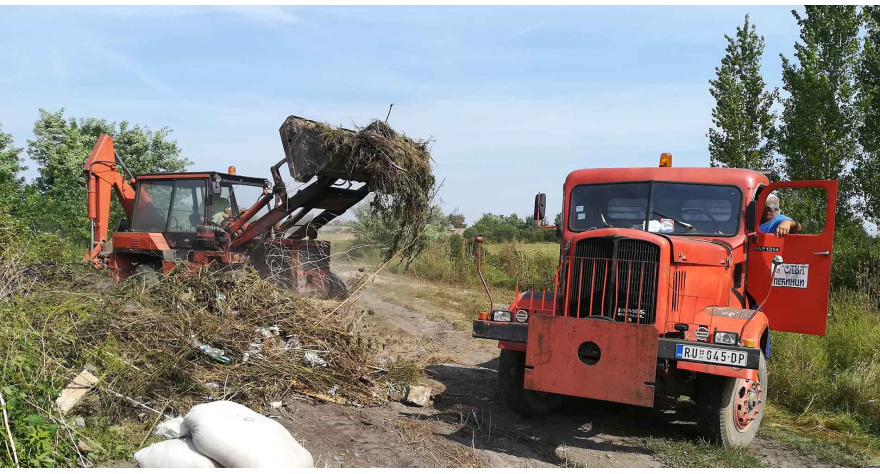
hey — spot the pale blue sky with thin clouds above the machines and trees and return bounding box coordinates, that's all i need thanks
[0,6,799,223]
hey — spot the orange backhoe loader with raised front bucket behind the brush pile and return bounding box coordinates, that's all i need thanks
[83,116,370,298]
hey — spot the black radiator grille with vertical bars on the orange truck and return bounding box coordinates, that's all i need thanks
[568,237,660,324]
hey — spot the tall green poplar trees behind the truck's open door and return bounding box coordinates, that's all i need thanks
[708,5,880,286]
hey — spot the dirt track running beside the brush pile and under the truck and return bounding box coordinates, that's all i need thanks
[276,265,840,467]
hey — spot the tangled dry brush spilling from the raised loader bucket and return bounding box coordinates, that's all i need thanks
[318,120,436,264]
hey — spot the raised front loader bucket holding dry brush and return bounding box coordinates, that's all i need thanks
[279,115,367,183]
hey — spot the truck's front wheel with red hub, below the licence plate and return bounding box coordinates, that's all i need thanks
[697,354,768,447]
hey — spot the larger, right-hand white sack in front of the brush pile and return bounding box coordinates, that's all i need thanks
[184,400,314,468]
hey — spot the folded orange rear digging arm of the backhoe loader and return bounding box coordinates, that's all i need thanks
[83,135,135,268]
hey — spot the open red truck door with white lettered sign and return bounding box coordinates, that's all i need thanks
[746,181,837,336]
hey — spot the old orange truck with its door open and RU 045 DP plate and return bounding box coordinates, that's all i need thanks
[473,153,837,446]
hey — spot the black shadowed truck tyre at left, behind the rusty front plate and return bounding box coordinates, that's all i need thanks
[498,349,562,418]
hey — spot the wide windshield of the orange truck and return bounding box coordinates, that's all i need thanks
[568,183,742,236]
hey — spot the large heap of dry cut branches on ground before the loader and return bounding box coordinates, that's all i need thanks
[7,266,404,413]
